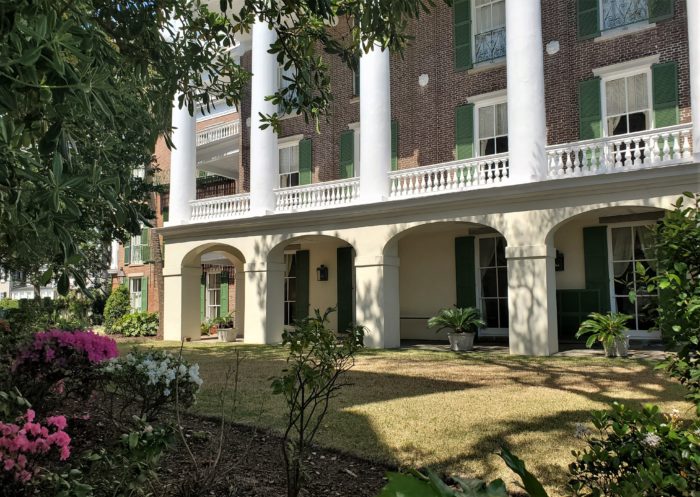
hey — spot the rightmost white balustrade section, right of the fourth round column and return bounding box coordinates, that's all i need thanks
[547,124,692,178]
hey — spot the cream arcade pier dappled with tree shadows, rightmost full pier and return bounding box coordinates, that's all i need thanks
[506,245,559,356]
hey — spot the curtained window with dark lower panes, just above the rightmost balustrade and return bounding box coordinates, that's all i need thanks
[603,70,652,136]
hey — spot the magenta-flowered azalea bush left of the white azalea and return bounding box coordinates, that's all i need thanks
[11,330,118,410]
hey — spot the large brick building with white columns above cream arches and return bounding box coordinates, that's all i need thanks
[153,0,700,354]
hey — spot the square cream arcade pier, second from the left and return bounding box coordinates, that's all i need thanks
[244,262,286,344]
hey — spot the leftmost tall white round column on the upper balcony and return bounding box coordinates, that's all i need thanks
[168,97,197,225]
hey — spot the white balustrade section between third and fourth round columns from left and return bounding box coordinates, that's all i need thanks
[389,153,509,199]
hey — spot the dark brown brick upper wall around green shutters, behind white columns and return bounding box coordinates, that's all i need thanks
[240,0,690,191]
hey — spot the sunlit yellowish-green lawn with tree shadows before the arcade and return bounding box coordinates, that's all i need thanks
[121,342,690,495]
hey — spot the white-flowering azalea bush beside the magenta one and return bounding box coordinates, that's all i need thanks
[101,350,203,420]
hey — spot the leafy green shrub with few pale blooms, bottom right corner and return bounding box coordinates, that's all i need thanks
[569,403,700,497]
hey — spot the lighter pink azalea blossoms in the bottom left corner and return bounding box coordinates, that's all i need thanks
[0,409,71,483]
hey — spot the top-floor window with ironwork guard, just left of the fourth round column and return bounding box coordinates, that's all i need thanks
[473,0,506,64]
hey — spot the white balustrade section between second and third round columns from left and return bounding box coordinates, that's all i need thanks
[275,178,360,212]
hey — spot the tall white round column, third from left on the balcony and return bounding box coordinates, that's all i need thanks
[360,47,391,202]
